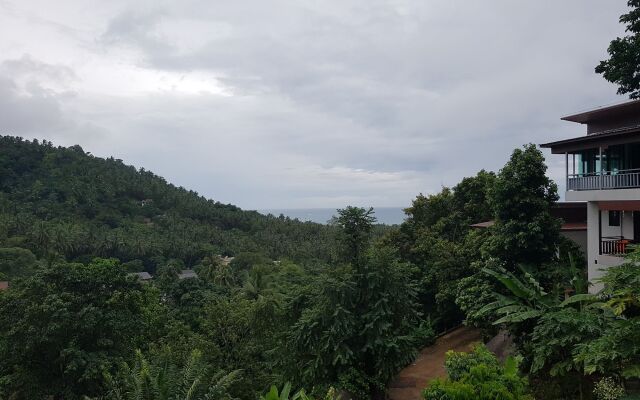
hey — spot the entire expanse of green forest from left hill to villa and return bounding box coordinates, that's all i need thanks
[0,137,640,400]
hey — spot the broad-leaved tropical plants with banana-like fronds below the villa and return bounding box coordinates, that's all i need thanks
[483,250,640,395]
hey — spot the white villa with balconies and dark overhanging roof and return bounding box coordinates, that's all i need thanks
[541,100,640,292]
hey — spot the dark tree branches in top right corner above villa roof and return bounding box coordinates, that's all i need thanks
[596,0,640,99]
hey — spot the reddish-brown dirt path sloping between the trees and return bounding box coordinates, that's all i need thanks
[389,327,482,400]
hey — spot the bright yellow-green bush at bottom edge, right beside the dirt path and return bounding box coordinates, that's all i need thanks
[423,346,533,400]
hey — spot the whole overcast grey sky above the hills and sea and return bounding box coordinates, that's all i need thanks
[0,0,626,209]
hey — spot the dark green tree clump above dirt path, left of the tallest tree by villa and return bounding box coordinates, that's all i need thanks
[396,171,495,330]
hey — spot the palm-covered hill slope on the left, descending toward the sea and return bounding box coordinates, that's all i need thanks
[0,136,332,273]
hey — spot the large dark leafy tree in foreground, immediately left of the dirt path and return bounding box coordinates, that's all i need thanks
[288,248,422,396]
